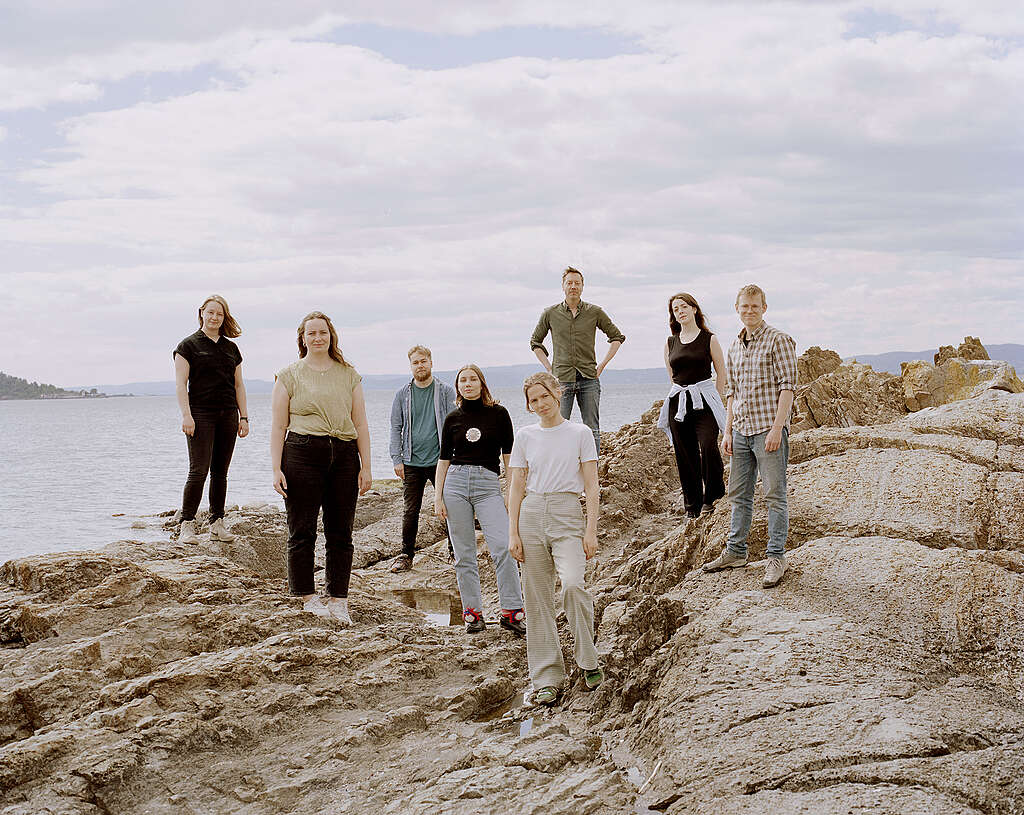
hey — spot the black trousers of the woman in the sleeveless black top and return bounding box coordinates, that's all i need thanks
[669,394,725,514]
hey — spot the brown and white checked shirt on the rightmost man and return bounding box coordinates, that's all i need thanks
[725,323,797,436]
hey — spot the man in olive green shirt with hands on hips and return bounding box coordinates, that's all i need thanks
[529,266,626,452]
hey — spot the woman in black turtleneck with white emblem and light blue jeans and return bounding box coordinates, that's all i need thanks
[434,364,526,636]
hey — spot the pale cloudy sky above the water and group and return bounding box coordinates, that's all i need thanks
[0,0,1024,386]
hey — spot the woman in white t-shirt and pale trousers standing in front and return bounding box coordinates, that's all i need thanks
[509,373,604,704]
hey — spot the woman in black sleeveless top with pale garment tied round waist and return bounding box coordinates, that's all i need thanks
[665,292,726,518]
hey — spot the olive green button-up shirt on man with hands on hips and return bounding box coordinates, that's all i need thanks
[529,300,626,382]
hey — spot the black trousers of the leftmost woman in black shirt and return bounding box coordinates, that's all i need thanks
[181,408,239,522]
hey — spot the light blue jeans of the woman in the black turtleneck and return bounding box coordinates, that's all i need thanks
[443,464,522,614]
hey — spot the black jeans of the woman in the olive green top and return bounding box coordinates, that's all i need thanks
[281,433,359,597]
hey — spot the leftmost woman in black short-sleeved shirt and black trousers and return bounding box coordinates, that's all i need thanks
[173,294,249,544]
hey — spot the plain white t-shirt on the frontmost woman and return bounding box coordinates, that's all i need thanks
[509,421,597,495]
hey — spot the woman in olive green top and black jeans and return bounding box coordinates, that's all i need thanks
[270,311,373,626]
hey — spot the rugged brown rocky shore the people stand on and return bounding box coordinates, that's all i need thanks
[0,343,1024,815]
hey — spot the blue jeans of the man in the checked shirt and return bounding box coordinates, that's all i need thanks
[726,428,790,557]
